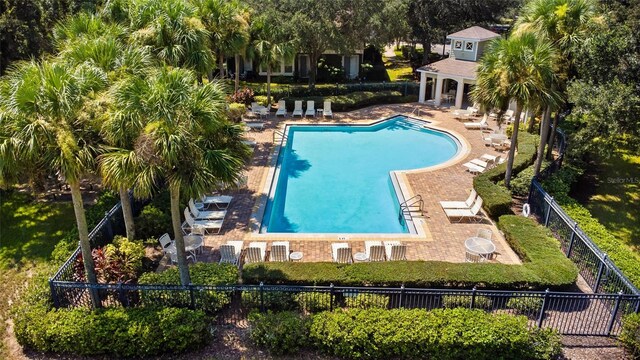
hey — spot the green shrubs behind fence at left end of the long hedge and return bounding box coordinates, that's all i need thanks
[138,263,238,313]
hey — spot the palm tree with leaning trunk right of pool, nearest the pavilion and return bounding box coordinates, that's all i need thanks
[474,32,555,187]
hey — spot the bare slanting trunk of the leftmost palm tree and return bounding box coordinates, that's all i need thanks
[69,181,101,308]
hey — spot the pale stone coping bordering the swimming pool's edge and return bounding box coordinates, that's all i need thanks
[247,113,471,241]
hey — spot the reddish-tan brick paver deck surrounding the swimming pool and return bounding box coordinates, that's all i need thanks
[169,103,520,264]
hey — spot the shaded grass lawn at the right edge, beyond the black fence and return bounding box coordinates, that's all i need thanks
[585,152,640,253]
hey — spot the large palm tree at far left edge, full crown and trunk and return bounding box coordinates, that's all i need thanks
[0,61,106,307]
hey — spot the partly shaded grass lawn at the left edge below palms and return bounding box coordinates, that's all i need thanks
[0,192,75,359]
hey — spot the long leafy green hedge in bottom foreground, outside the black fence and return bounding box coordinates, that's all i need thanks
[309,308,560,359]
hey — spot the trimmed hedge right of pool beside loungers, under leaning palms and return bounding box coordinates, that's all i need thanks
[473,132,539,219]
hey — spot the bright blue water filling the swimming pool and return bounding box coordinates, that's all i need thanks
[261,116,458,233]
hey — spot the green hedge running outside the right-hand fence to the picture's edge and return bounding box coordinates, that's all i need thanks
[542,166,640,287]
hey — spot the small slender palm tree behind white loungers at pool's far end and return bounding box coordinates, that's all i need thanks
[252,13,295,106]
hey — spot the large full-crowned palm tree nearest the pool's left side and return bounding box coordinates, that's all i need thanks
[110,67,248,285]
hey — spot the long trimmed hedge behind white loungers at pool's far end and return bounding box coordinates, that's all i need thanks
[284,91,418,111]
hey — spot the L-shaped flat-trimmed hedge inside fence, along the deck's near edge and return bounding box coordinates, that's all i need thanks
[242,215,578,289]
